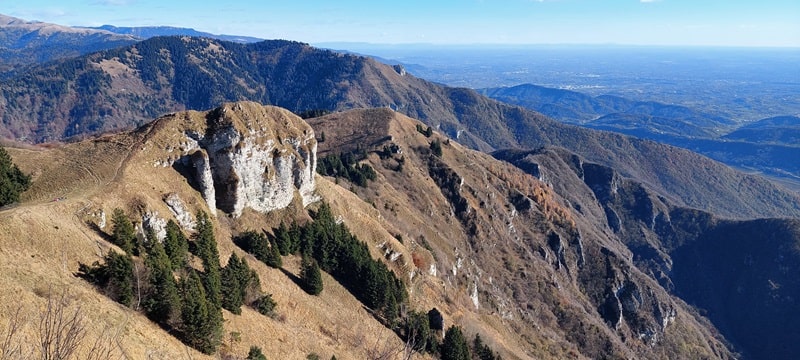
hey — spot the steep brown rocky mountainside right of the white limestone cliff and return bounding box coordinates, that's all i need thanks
[309,109,734,359]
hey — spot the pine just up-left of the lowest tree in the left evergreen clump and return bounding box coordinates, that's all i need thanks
[144,241,180,324]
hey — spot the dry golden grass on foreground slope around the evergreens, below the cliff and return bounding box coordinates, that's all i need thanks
[0,105,422,359]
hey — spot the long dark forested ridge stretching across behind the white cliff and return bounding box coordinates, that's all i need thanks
[0,37,800,222]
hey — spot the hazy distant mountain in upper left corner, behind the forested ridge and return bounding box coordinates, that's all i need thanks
[0,14,139,73]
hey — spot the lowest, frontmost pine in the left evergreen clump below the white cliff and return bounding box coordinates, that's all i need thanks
[180,271,222,354]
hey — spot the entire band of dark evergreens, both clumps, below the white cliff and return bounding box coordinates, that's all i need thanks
[77,203,500,360]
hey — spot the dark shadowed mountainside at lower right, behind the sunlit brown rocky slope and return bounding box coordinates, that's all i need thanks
[495,148,800,359]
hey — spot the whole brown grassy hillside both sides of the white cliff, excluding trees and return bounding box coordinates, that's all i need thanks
[0,104,752,359]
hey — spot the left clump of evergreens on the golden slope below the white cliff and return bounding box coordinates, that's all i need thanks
[77,209,275,354]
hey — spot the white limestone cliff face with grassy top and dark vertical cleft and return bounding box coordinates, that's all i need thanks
[155,102,317,217]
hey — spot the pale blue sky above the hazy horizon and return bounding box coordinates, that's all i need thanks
[0,0,800,47]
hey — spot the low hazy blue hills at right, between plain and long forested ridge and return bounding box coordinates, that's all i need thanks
[481,84,800,181]
